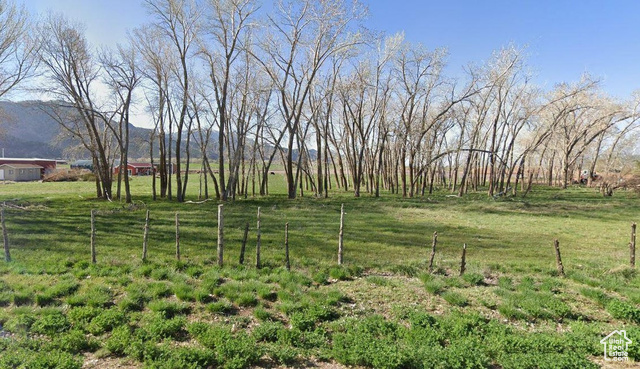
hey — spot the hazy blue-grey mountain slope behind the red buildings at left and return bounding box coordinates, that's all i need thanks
[0,101,151,159]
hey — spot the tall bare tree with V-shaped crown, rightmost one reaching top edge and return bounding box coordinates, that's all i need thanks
[254,0,362,199]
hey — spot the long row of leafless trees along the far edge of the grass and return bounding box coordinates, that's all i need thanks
[0,0,640,202]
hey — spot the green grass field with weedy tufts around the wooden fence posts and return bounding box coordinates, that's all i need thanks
[0,175,640,368]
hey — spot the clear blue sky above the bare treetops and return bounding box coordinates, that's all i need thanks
[23,0,640,98]
